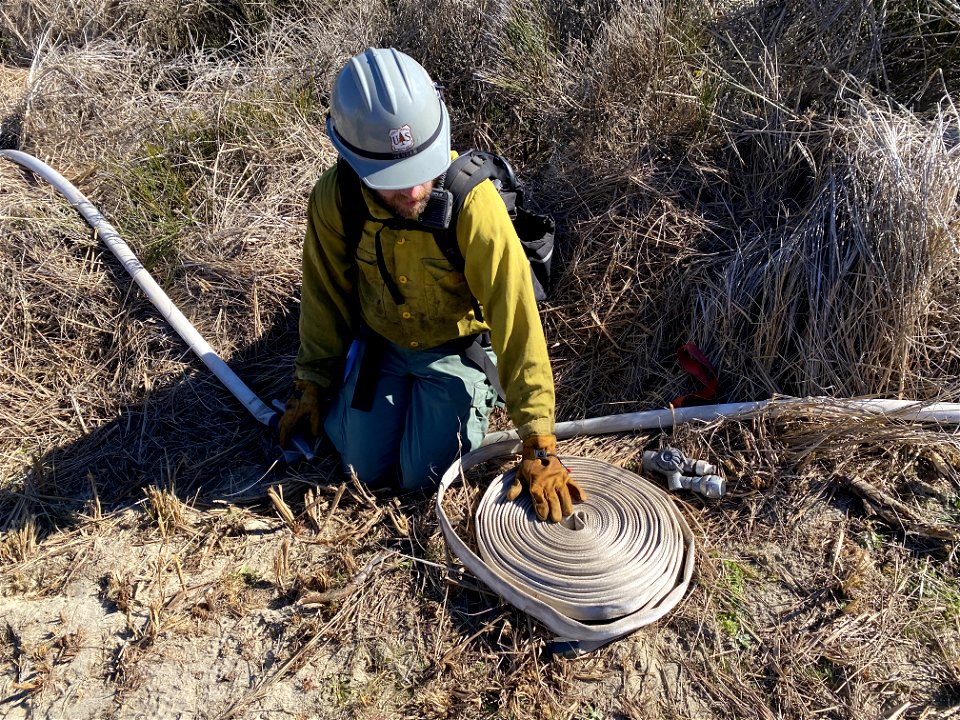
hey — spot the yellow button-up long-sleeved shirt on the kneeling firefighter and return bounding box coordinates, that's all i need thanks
[296,159,555,437]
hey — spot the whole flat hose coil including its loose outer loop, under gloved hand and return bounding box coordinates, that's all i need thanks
[436,440,694,654]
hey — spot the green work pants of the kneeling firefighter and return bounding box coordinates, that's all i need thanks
[324,341,497,489]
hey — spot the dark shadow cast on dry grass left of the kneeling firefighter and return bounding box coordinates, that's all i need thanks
[0,315,340,540]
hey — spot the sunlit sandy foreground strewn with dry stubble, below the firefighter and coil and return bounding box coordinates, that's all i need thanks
[0,434,960,720]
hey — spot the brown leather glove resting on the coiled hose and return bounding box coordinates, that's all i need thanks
[507,435,587,522]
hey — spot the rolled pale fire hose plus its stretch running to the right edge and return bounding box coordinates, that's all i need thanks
[435,398,960,654]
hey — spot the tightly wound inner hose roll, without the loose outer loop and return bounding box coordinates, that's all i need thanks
[476,457,694,622]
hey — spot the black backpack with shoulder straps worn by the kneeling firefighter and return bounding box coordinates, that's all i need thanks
[337,150,556,320]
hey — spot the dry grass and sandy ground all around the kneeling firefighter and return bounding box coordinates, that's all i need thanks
[0,0,960,720]
